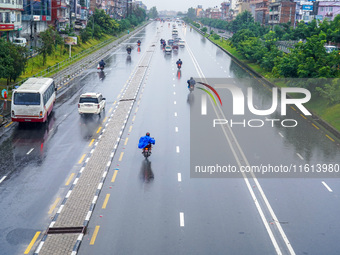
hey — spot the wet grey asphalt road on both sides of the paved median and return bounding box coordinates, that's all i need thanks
[0,22,340,254]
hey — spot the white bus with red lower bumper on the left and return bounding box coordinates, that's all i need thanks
[11,78,57,122]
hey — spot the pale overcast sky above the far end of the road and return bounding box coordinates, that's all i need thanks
[142,0,223,12]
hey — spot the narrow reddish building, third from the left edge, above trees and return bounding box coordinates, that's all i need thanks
[49,0,70,31]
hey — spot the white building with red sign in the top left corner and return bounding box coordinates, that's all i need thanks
[0,0,24,40]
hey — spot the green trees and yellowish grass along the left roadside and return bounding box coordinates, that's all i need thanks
[0,8,146,90]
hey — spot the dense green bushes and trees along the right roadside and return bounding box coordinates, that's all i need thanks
[186,12,340,130]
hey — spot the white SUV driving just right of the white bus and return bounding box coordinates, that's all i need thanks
[78,93,106,116]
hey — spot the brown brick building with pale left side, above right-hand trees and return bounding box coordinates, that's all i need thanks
[268,0,296,25]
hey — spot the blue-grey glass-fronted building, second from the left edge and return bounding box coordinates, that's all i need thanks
[21,0,52,46]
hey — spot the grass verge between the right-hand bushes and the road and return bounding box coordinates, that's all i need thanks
[209,34,340,131]
